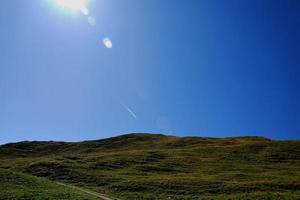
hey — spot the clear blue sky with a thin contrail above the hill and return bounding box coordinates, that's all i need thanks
[0,0,300,143]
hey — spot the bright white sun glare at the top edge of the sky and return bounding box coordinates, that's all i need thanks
[55,0,89,15]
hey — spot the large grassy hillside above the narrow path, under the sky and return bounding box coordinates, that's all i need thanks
[0,134,300,200]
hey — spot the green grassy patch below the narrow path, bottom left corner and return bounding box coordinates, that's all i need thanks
[0,169,96,200]
